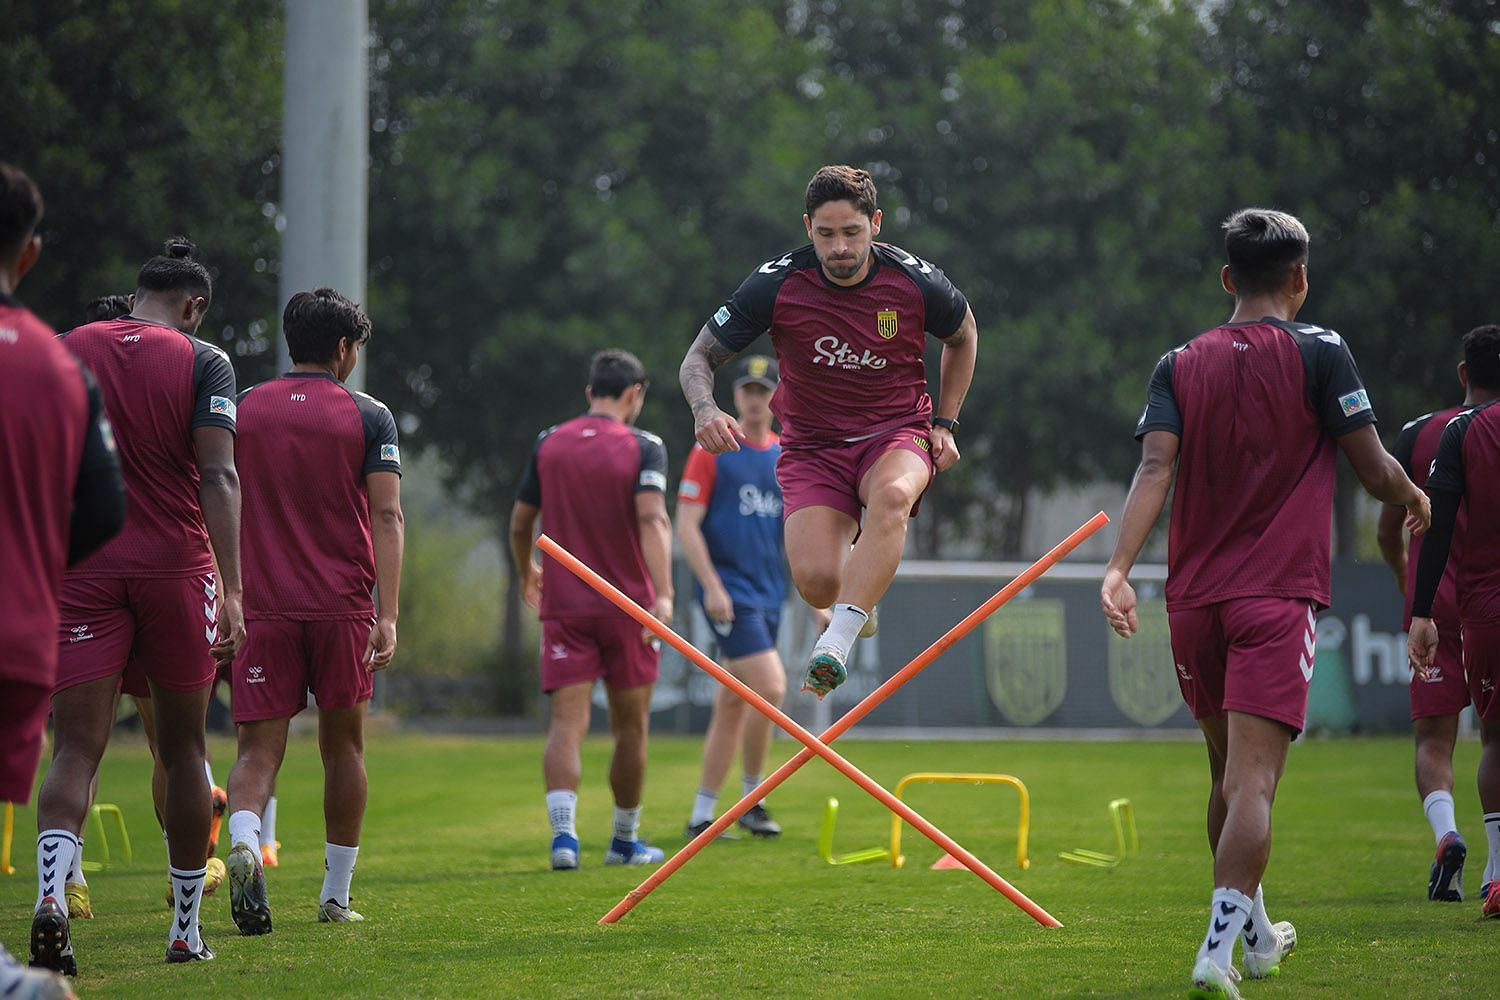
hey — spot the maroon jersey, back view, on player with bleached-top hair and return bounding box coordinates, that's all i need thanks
[1136,319,1376,610]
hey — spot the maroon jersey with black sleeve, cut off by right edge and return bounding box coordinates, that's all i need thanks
[1427,403,1500,624]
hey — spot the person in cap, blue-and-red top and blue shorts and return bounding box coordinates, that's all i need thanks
[677,355,827,837]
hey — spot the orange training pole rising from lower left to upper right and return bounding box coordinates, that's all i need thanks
[599,511,1110,924]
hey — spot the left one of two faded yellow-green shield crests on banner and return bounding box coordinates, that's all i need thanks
[984,600,1068,726]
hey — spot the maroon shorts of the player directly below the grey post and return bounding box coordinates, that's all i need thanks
[230,618,375,723]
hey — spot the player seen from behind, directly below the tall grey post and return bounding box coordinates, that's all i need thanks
[219,288,405,934]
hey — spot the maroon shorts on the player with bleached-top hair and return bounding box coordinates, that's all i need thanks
[1167,597,1317,733]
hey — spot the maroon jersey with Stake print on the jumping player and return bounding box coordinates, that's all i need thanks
[708,243,969,448]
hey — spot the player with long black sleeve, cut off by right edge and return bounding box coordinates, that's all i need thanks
[1409,327,1500,918]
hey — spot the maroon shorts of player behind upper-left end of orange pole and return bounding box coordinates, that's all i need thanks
[542,616,662,694]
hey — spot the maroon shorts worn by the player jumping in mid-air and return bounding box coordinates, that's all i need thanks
[776,421,933,522]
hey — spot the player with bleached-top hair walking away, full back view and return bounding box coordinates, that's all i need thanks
[1100,208,1428,997]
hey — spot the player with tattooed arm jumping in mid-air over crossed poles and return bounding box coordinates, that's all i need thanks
[680,166,978,699]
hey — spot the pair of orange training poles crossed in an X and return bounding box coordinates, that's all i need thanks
[537,511,1110,927]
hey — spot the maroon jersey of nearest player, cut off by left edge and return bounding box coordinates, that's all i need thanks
[0,295,119,687]
